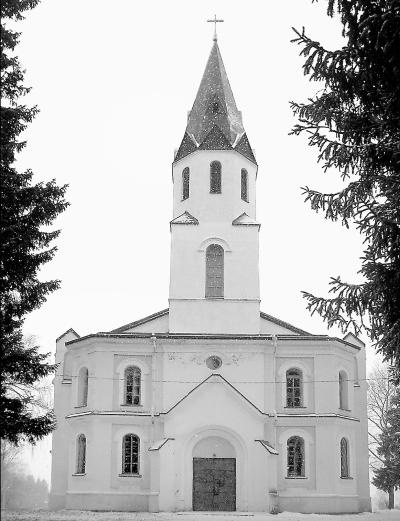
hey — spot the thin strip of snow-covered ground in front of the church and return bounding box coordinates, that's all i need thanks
[1,510,400,521]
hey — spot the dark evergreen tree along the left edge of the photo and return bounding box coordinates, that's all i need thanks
[0,0,67,443]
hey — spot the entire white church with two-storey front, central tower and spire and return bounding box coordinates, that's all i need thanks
[50,35,370,513]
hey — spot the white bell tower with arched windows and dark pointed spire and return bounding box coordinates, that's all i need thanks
[169,36,260,334]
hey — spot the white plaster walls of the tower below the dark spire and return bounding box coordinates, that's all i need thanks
[169,147,260,334]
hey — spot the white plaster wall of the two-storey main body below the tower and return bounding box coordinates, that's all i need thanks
[52,338,369,512]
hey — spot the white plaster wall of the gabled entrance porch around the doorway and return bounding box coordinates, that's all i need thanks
[161,383,268,511]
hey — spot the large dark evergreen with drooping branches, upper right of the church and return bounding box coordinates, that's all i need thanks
[291,0,400,381]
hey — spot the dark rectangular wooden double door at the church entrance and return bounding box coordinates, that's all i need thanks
[193,458,236,512]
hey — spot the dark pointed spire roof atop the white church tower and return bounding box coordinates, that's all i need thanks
[175,39,256,163]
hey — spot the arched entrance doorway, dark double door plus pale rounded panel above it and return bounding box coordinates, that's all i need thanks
[193,436,236,512]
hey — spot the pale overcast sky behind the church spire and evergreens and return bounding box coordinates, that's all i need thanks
[12,0,382,480]
